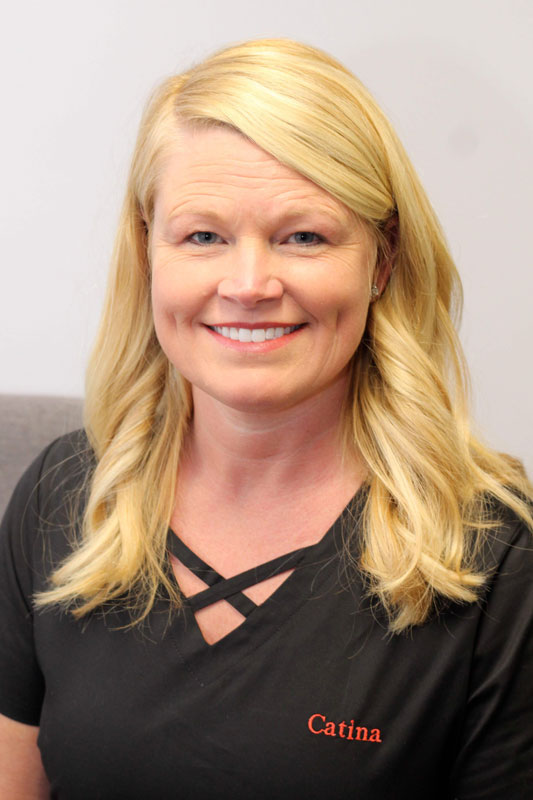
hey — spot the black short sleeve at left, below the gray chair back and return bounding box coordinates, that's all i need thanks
[0,445,58,725]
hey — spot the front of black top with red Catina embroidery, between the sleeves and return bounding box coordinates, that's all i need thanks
[34,564,474,800]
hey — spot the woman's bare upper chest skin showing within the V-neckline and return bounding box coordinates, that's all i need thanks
[169,487,358,645]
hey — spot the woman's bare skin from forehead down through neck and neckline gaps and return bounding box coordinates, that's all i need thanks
[150,128,386,644]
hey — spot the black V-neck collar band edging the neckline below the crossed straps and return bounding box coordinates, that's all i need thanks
[168,488,364,686]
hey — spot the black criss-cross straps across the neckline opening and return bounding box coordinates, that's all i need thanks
[168,530,309,617]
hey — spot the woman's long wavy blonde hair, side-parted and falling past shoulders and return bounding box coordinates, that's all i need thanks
[37,39,532,631]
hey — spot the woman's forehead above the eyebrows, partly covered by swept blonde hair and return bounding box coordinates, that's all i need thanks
[155,126,355,223]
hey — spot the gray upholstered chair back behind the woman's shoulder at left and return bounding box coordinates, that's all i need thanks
[0,394,82,517]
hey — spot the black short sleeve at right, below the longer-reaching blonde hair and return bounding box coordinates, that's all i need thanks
[450,522,533,800]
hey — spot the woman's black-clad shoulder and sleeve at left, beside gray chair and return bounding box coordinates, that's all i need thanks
[0,431,92,725]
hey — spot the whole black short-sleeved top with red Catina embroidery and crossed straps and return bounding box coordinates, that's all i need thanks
[0,434,533,800]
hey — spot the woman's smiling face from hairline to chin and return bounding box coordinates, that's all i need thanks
[150,128,376,411]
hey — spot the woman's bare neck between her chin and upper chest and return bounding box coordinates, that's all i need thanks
[182,378,363,500]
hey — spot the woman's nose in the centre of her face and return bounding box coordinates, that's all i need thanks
[218,242,283,308]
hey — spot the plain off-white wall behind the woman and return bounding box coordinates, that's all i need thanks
[0,0,533,473]
